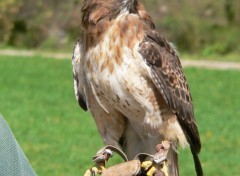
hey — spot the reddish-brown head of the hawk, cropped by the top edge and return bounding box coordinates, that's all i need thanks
[82,0,155,33]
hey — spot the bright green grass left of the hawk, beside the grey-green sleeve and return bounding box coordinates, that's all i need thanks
[0,57,102,176]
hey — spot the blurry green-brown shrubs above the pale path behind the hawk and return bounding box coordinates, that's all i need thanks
[0,0,240,56]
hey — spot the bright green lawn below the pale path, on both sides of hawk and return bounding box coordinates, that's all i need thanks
[0,56,240,176]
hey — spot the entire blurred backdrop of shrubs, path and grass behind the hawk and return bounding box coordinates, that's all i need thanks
[0,0,240,176]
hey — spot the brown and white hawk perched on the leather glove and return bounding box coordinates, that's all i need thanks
[72,0,203,176]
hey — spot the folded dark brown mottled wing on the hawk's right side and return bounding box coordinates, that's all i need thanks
[139,30,201,153]
